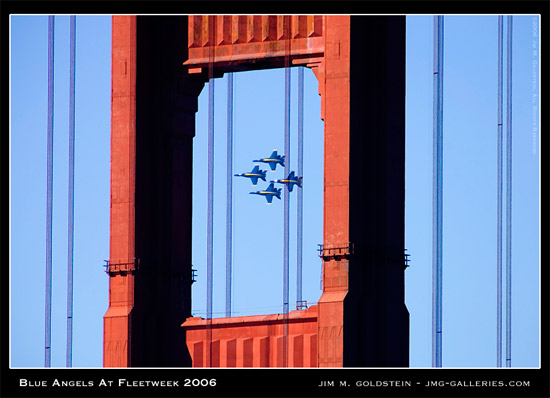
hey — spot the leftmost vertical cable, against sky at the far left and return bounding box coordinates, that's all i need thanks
[44,15,55,368]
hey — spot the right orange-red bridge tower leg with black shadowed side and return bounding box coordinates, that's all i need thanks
[318,16,409,367]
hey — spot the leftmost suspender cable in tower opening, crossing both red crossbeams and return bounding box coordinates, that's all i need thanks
[206,16,215,367]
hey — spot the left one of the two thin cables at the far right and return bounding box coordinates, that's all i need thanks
[497,15,503,368]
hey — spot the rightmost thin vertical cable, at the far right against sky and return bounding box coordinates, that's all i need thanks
[506,15,513,368]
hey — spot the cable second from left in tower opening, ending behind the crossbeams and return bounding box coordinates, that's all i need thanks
[225,73,233,317]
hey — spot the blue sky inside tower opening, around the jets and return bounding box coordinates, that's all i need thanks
[191,68,324,318]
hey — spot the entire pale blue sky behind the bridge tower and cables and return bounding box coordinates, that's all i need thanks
[10,15,540,367]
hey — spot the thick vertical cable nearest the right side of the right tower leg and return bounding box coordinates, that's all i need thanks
[432,15,443,368]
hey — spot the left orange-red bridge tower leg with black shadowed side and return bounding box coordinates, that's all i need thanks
[104,16,204,367]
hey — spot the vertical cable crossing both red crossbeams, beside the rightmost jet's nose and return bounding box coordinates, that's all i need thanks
[283,16,290,367]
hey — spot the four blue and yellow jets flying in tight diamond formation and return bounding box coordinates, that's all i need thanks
[235,149,303,204]
